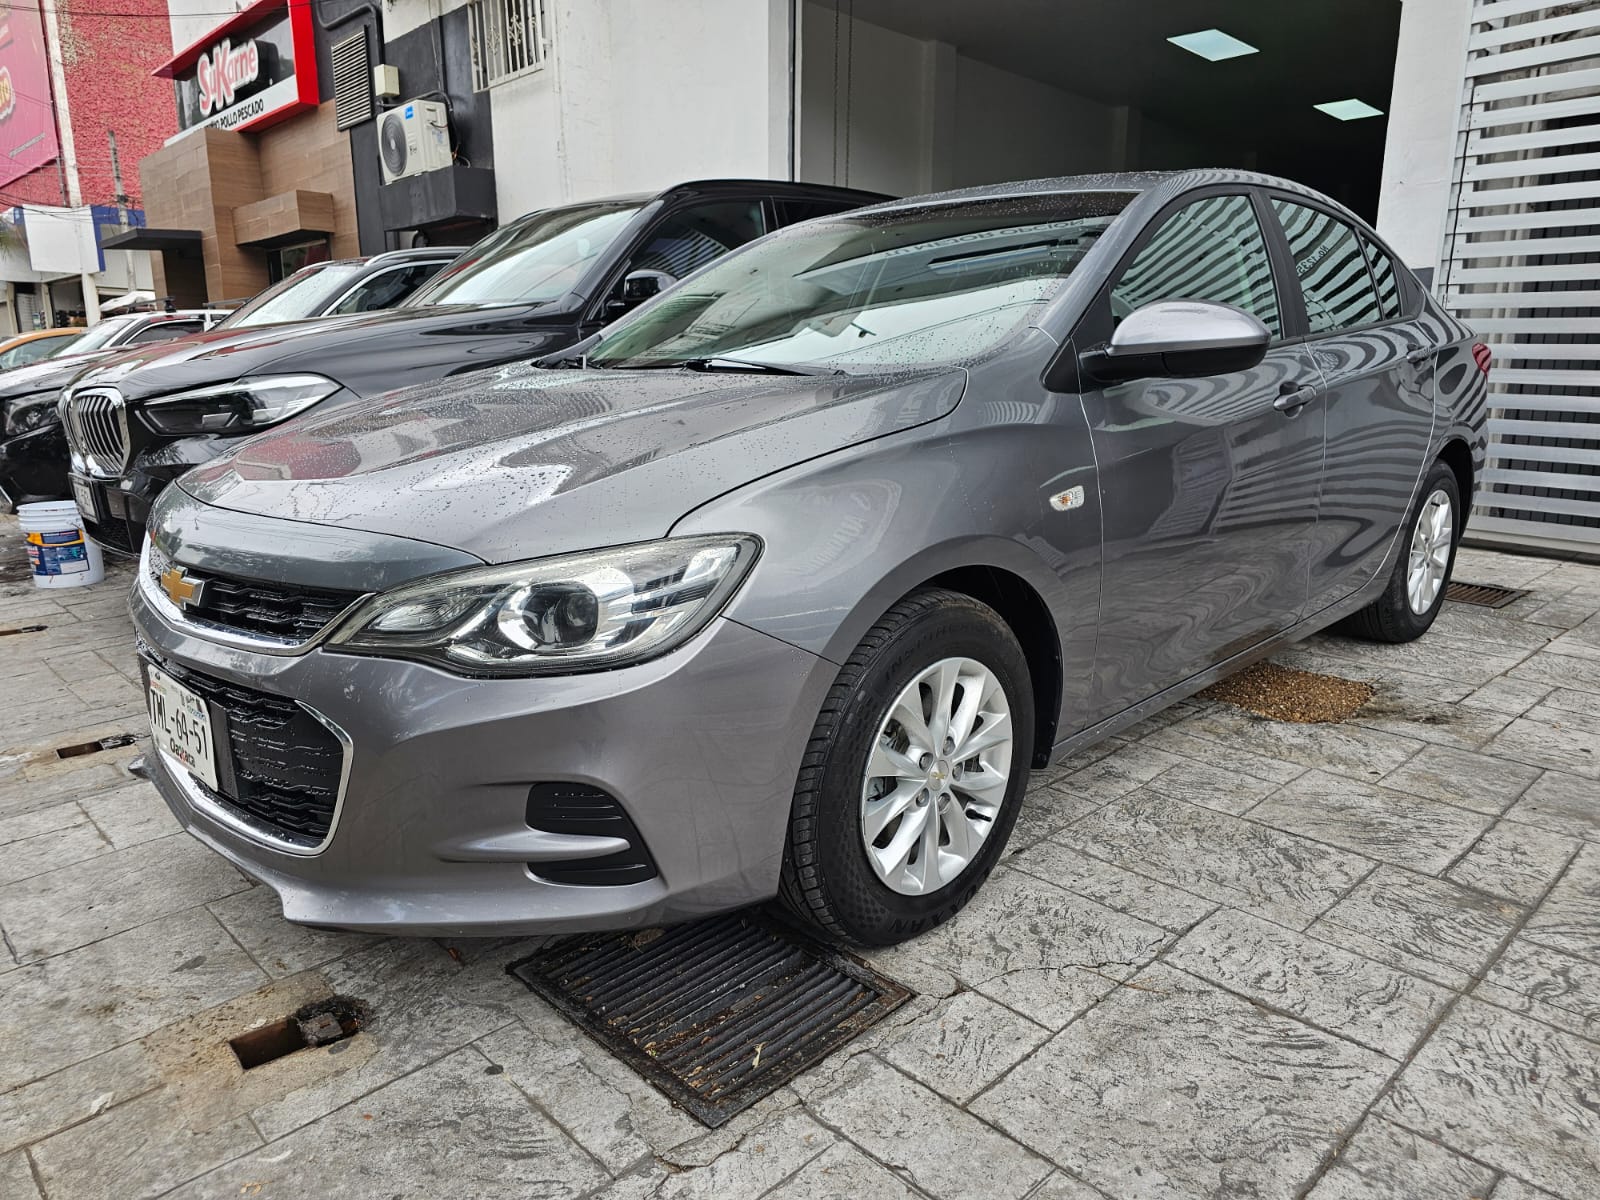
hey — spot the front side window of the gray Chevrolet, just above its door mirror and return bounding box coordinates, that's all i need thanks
[1110,195,1283,338]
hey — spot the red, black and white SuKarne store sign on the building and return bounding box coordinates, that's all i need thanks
[155,0,317,130]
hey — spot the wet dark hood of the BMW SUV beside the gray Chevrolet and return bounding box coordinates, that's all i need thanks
[78,304,547,400]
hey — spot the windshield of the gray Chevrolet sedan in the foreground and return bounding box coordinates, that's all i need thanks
[589,192,1133,370]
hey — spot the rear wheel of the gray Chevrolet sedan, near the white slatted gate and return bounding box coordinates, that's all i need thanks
[1339,462,1462,642]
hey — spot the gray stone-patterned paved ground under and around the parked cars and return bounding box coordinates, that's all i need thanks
[0,526,1600,1200]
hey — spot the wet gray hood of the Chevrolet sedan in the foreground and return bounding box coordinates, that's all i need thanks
[179,365,966,562]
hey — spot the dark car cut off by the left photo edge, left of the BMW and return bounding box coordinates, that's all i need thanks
[0,309,229,502]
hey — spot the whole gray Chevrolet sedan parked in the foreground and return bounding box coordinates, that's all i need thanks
[133,171,1490,944]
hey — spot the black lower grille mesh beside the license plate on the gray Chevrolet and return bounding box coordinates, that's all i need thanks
[146,651,344,848]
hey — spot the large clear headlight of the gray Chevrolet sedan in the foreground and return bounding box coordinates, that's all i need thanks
[328,534,760,675]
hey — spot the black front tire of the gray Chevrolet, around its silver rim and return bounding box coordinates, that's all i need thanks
[778,589,1034,946]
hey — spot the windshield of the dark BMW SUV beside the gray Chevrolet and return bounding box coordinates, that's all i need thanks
[403,202,643,309]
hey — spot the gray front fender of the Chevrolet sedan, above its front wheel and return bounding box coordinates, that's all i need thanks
[672,333,1101,742]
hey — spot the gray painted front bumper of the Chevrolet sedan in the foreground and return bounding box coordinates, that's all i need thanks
[133,589,835,936]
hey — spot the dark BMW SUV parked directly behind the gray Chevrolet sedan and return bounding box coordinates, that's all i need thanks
[62,179,883,552]
